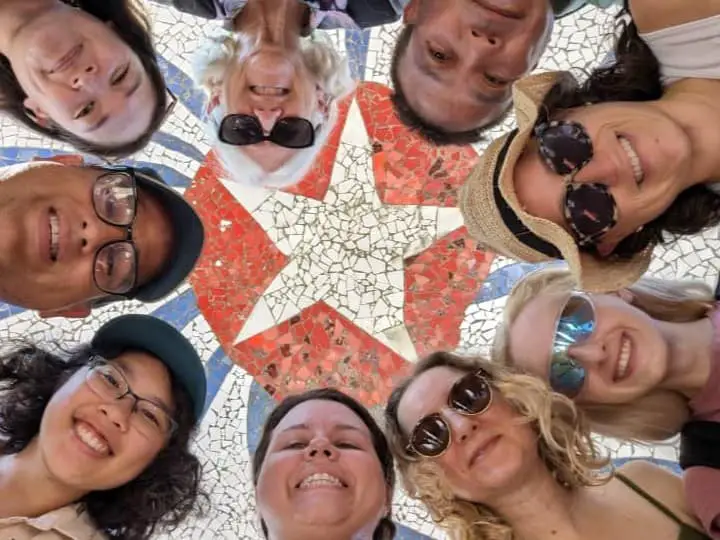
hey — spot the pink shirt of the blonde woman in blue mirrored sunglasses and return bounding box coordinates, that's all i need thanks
[684,309,720,540]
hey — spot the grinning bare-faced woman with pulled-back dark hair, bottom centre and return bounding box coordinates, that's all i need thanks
[252,388,395,540]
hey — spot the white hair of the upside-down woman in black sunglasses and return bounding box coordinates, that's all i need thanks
[195,31,355,188]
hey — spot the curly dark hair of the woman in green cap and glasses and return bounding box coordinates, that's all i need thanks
[0,343,205,540]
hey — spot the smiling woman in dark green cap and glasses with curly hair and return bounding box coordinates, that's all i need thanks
[0,315,206,540]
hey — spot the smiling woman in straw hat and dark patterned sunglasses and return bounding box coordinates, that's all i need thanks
[460,0,720,291]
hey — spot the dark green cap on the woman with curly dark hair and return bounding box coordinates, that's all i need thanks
[92,315,207,423]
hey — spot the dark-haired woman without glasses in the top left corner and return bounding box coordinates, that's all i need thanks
[0,0,171,157]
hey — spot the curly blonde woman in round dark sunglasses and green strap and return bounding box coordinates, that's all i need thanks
[385,352,707,540]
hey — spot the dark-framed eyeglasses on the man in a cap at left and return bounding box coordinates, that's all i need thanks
[92,171,138,295]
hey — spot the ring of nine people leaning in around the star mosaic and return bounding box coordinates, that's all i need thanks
[0,0,720,540]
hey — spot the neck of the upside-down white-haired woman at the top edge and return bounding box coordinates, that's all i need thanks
[233,0,308,49]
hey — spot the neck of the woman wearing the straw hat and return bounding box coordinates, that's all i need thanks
[657,79,720,189]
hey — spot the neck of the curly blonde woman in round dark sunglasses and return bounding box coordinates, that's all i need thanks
[486,466,580,540]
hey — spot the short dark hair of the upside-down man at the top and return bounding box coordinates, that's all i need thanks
[390,24,507,146]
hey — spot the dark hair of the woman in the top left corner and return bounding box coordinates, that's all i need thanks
[0,0,168,157]
